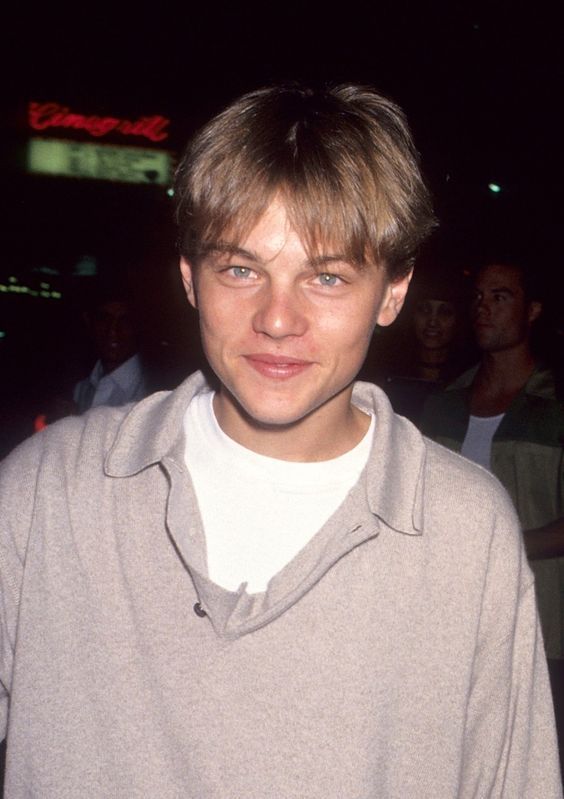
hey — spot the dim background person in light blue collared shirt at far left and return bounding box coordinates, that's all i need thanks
[73,289,149,413]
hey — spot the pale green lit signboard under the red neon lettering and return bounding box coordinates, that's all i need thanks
[27,138,172,186]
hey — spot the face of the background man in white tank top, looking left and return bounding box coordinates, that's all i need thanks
[472,264,540,352]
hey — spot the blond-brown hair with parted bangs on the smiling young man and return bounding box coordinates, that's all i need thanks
[175,85,435,280]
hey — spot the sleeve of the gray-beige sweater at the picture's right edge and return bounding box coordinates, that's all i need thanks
[459,508,562,799]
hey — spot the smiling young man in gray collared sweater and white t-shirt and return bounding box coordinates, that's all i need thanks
[0,86,561,799]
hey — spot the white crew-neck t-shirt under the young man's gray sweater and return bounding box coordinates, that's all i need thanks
[184,391,374,593]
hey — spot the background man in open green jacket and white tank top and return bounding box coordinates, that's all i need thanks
[422,259,564,768]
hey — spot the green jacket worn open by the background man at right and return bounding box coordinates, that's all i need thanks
[421,366,564,658]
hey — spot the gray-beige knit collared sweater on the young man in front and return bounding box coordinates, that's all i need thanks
[0,375,561,799]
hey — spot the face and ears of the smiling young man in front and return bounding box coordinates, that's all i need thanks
[181,201,409,432]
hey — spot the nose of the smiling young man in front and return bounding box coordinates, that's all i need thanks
[253,284,308,339]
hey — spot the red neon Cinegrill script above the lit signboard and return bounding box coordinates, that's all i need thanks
[28,103,170,141]
